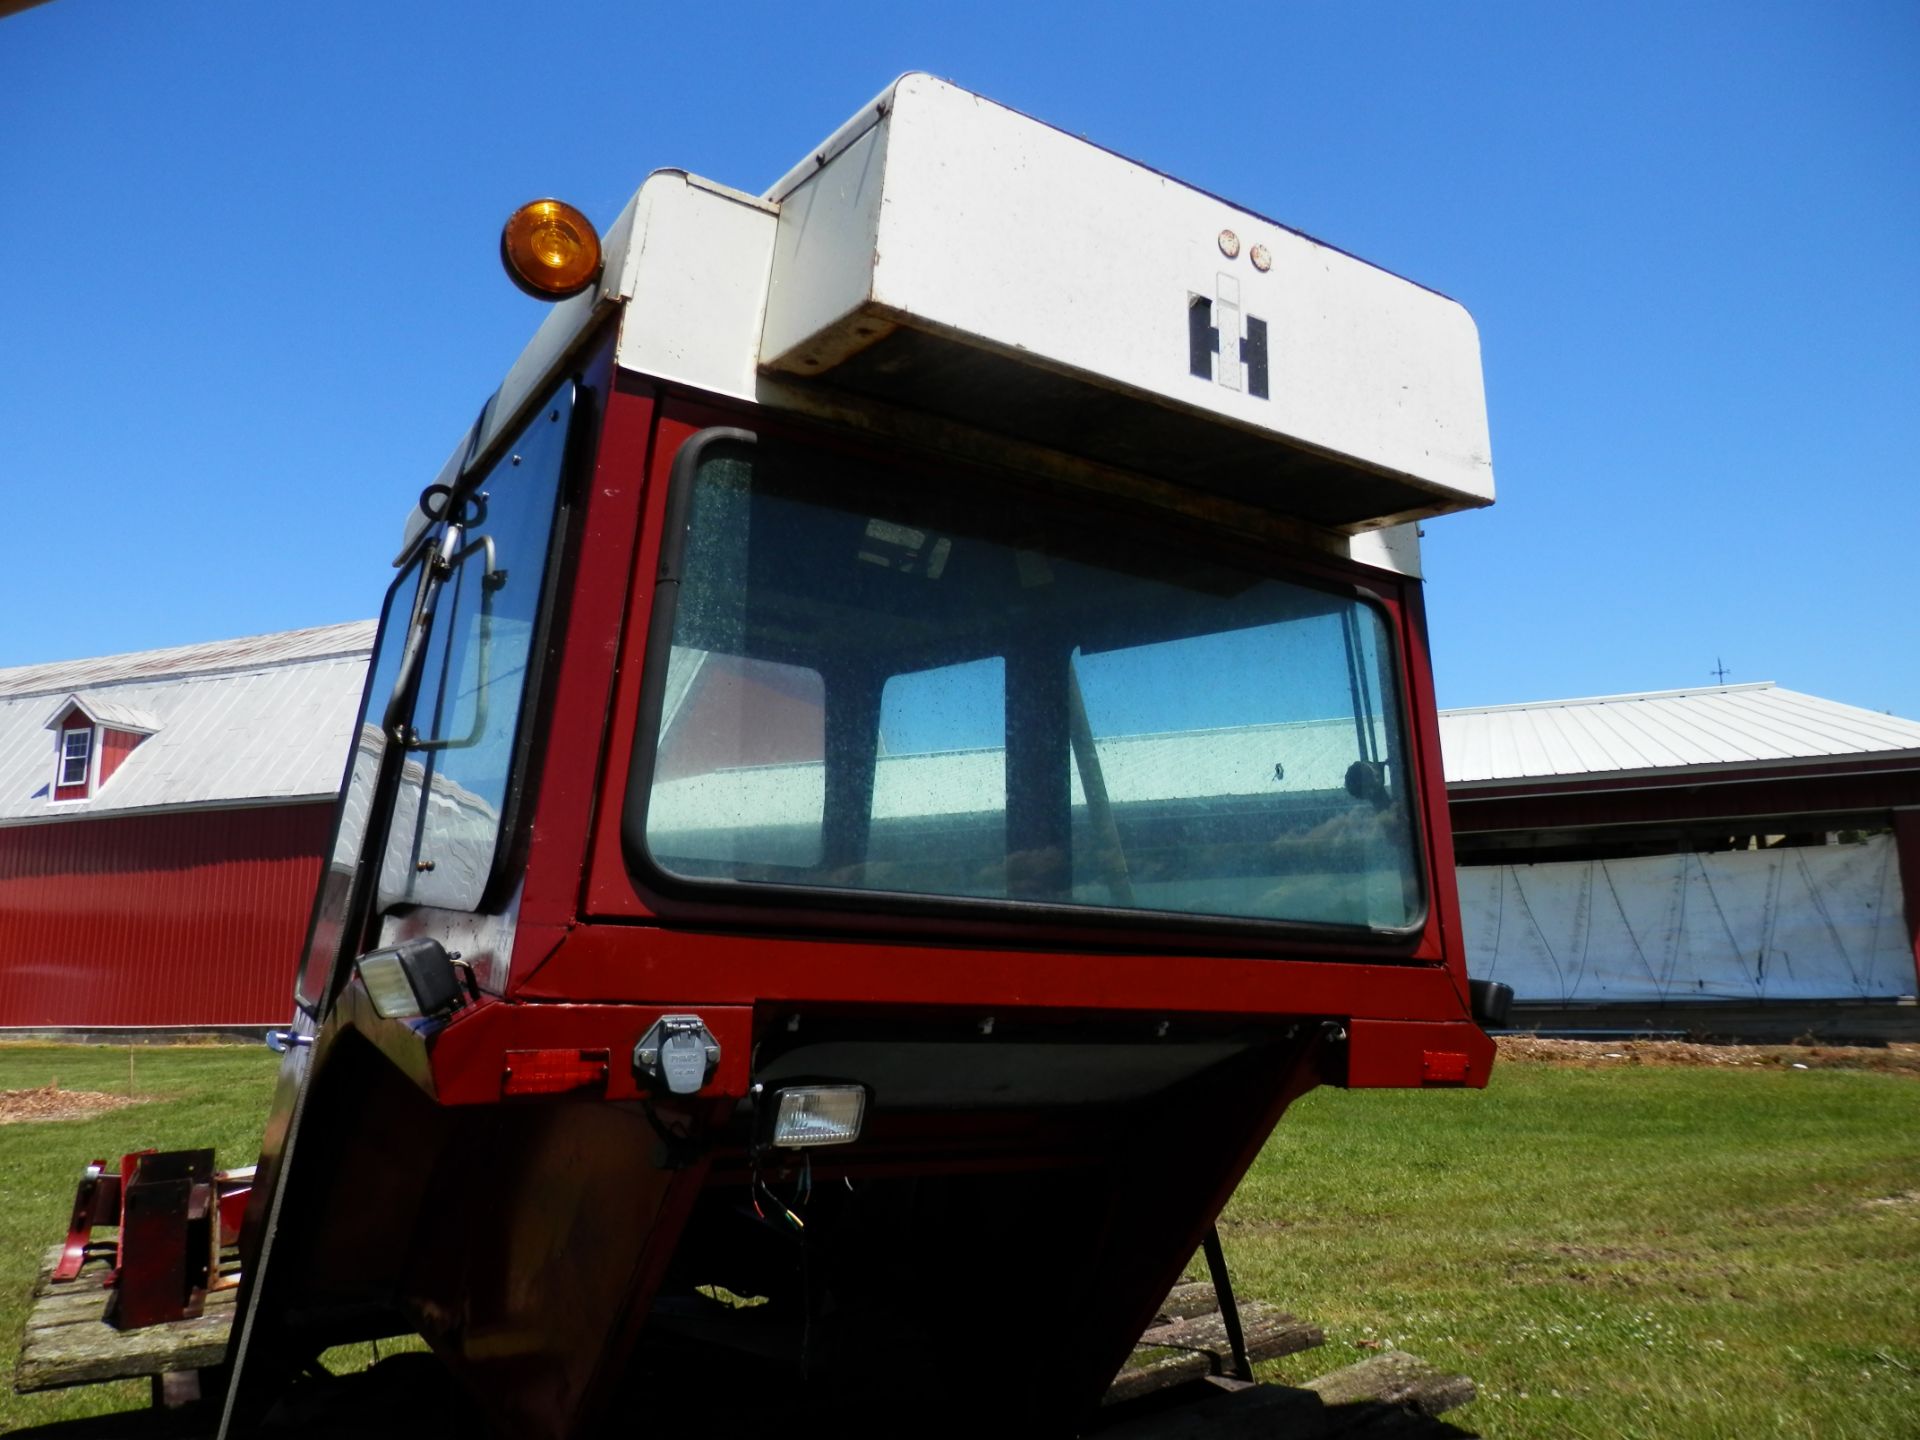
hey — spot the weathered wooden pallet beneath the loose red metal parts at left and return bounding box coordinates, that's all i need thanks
[13,1240,238,1394]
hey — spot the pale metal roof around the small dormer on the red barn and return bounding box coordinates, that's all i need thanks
[0,620,374,826]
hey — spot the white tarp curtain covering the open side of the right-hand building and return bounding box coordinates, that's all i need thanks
[1459,835,1914,1004]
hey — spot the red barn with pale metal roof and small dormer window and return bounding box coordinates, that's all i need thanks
[0,622,372,1029]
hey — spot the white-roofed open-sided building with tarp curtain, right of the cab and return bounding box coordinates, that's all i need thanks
[1440,684,1920,1035]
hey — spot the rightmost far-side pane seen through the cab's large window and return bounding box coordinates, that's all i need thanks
[1073,601,1421,927]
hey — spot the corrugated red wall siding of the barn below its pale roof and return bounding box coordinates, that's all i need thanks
[0,803,334,1025]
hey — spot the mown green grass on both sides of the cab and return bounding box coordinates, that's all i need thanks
[0,1044,1920,1438]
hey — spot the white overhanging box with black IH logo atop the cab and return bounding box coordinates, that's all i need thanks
[760,75,1494,505]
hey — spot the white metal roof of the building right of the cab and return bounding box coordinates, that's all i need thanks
[1440,680,1920,785]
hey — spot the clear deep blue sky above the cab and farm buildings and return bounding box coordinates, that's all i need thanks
[0,0,1920,718]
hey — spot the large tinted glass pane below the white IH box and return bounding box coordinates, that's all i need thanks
[630,440,1423,929]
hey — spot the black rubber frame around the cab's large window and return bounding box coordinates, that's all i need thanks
[620,424,1438,962]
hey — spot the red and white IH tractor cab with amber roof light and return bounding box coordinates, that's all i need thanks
[37,75,1492,1436]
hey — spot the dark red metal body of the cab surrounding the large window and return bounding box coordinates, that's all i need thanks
[210,353,1492,1434]
